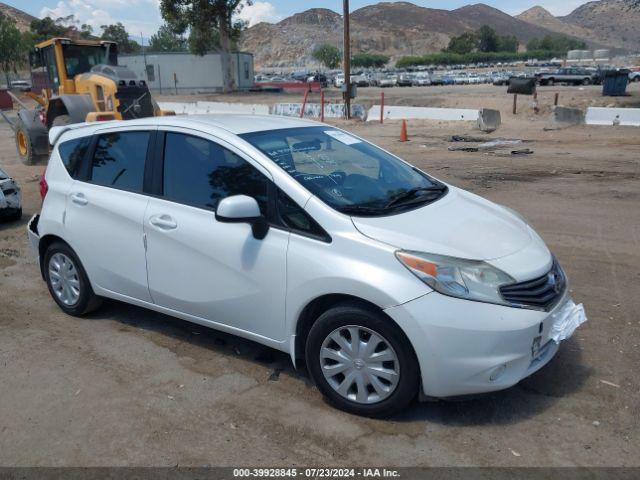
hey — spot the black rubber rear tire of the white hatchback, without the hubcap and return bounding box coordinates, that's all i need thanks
[42,242,102,317]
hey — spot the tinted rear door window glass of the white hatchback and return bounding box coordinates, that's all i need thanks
[91,132,151,193]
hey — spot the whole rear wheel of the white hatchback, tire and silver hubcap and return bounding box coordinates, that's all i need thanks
[43,242,102,316]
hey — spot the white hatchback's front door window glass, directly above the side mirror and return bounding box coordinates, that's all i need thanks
[162,132,269,215]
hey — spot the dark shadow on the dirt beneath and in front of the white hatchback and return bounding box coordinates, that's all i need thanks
[88,301,593,426]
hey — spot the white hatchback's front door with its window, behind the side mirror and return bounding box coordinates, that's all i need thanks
[144,128,289,342]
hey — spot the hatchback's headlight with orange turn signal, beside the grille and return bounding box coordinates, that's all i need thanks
[396,250,515,305]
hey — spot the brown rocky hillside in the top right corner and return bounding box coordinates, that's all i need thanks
[560,0,640,51]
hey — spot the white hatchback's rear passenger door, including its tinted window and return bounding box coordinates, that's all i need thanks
[65,127,155,302]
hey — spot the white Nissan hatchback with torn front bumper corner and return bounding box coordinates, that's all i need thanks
[28,115,585,416]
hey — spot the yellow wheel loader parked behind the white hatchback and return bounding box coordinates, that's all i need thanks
[12,38,172,165]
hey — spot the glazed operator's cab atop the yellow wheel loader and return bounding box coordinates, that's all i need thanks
[29,38,118,95]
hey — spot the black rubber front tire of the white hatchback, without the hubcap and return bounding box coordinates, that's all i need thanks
[305,302,420,418]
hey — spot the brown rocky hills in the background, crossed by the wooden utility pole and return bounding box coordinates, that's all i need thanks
[241,0,620,68]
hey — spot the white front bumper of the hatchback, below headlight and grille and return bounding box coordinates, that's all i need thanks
[385,292,571,398]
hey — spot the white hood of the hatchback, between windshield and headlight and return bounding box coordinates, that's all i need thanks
[352,187,536,260]
